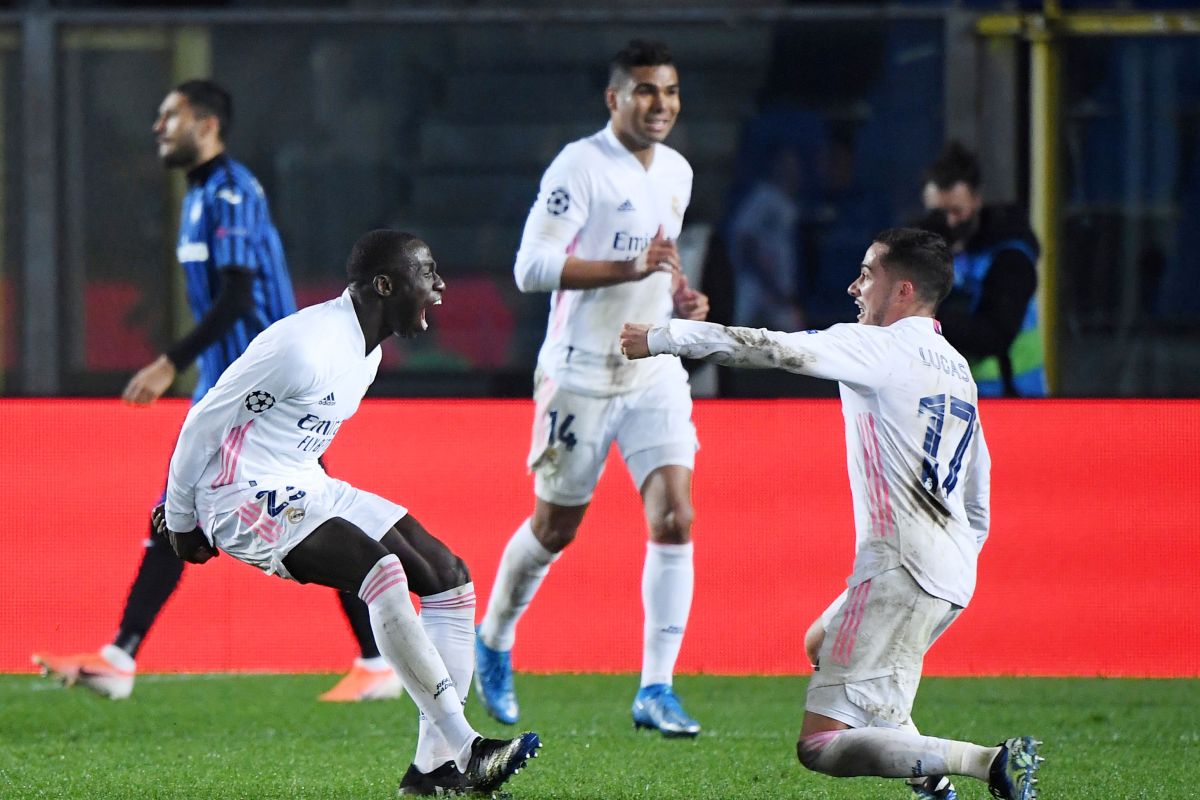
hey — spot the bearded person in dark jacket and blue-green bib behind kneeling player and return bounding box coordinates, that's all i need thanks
[919,142,1046,397]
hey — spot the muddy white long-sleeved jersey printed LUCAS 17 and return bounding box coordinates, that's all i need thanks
[649,317,991,606]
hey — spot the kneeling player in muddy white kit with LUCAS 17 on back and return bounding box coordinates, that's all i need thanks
[622,228,1042,800]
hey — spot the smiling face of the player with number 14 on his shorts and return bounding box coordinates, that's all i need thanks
[606,64,679,150]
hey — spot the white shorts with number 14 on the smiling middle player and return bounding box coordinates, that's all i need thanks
[527,369,700,506]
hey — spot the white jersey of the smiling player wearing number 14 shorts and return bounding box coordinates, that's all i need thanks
[514,125,691,396]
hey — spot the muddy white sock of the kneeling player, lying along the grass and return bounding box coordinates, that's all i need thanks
[800,728,998,781]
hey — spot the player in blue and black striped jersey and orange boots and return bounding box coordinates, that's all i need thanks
[32,80,403,700]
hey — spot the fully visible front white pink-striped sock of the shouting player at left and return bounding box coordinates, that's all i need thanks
[359,554,479,770]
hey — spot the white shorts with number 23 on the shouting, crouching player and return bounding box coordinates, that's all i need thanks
[200,473,408,579]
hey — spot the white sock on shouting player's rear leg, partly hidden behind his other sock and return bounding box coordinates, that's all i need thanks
[413,583,475,772]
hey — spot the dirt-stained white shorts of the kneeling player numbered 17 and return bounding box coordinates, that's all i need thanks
[804,567,962,728]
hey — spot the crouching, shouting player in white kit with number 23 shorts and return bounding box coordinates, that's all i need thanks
[156,230,540,795]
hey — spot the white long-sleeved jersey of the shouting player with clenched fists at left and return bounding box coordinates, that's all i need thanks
[167,289,382,531]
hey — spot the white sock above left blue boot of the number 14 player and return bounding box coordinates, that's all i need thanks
[479,519,559,651]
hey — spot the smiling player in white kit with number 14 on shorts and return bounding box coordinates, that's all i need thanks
[475,41,708,736]
